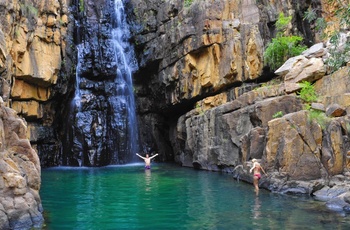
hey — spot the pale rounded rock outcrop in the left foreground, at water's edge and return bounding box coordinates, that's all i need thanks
[0,99,43,229]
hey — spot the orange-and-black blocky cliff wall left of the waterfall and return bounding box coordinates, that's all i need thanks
[0,0,75,166]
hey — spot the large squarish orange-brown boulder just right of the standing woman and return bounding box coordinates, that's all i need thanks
[264,111,324,180]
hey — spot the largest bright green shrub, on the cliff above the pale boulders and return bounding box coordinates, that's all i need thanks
[264,13,307,70]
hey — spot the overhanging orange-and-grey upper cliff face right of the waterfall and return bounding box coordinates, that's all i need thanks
[130,0,321,156]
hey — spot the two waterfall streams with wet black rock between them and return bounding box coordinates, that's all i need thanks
[67,0,139,166]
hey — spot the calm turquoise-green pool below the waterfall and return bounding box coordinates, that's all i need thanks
[40,164,350,230]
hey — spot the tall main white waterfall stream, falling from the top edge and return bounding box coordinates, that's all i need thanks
[109,0,138,164]
